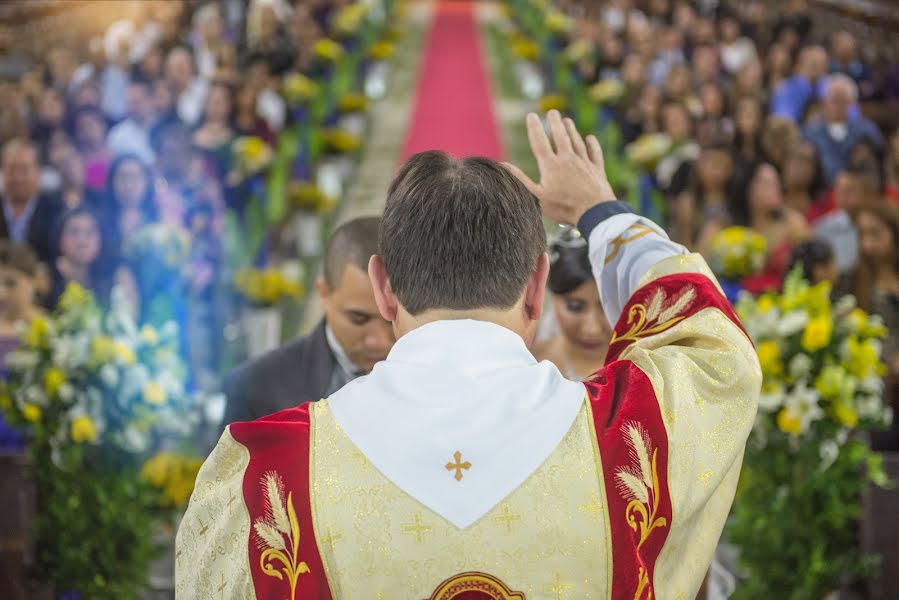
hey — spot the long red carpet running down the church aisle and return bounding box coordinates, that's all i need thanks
[402,2,503,159]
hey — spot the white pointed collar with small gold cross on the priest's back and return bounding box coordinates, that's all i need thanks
[328,320,586,529]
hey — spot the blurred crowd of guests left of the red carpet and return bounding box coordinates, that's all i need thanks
[0,0,358,386]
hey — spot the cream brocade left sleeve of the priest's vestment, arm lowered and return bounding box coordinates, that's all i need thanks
[175,429,256,600]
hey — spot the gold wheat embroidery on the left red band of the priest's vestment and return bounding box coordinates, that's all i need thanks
[253,471,309,600]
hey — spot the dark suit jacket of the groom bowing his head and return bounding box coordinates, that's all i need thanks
[221,319,337,429]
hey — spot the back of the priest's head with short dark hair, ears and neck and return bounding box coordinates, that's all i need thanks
[369,151,547,334]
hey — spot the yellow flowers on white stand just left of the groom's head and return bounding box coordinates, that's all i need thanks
[234,267,304,358]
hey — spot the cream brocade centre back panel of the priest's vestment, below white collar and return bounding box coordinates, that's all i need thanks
[311,401,610,600]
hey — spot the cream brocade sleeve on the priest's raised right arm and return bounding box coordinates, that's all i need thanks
[613,254,762,600]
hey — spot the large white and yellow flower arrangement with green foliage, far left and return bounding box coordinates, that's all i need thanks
[0,284,202,599]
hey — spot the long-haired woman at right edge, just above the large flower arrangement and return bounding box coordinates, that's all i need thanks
[850,199,899,375]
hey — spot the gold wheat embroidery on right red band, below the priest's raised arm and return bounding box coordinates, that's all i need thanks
[615,421,668,550]
